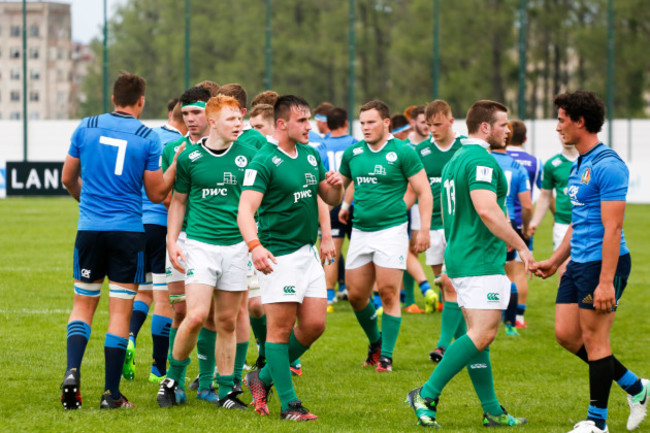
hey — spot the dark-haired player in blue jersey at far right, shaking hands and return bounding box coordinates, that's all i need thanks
[532,91,648,433]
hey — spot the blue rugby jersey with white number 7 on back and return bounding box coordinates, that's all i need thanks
[68,113,161,232]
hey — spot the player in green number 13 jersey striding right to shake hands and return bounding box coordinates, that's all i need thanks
[406,101,533,428]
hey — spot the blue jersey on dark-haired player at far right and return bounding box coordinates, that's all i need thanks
[568,143,630,263]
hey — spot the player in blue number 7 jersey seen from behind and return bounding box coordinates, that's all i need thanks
[61,72,176,409]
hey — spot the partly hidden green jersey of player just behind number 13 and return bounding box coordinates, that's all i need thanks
[415,135,465,230]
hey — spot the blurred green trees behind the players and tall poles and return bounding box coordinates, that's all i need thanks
[78,0,650,118]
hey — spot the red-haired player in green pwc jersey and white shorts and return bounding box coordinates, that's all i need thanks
[157,95,256,409]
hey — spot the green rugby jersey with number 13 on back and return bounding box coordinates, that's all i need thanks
[442,139,508,278]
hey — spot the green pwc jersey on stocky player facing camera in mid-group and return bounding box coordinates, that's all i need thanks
[339,136,422,232]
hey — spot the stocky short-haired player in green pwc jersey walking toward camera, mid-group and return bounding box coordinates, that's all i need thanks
[339,100,432,372]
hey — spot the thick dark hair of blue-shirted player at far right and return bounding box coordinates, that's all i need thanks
[553,90,605,134]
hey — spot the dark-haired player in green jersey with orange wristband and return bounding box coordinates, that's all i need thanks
[237,95,343,421]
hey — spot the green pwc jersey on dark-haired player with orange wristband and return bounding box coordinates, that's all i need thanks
[243,143,325,256]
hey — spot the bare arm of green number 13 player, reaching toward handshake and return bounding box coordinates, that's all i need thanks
[470,189,535,271]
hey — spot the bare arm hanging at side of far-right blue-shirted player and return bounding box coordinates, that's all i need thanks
[594,200,625,313]
